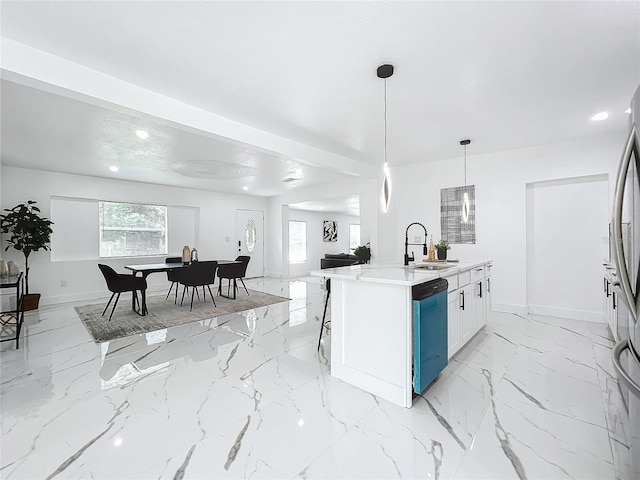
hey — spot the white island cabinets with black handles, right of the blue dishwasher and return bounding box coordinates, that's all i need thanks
[448,264,491,358]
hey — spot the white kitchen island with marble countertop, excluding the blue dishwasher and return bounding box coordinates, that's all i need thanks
[311,260,491,407]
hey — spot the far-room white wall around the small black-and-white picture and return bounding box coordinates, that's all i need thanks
[289,209,360,277]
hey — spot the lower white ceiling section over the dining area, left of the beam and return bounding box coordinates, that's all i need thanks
[0,81,350,196]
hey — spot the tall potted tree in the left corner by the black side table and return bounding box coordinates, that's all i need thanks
[0,200,53,310]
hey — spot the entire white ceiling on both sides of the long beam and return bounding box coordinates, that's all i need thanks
[0,1,640,204]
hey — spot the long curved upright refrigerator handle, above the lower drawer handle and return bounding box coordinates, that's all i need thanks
[613,125,640,322]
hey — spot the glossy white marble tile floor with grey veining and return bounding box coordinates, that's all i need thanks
[0,277,629,479]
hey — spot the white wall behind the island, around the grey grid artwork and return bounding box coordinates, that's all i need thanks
[378,135,625,313]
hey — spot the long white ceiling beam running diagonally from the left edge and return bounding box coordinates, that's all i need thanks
[0,37,377,177]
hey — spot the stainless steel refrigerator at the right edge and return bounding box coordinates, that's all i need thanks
[612,82,640,479]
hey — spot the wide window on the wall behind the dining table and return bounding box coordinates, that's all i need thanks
[99,202,167,258]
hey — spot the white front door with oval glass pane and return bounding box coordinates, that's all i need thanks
[236,209,264,278]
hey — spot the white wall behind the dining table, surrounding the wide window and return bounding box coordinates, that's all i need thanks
[1,166,267,304]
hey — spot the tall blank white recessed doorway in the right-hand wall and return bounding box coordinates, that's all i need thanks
[526,175,609,322]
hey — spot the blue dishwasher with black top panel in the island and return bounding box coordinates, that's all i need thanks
[411,278,449,394]
